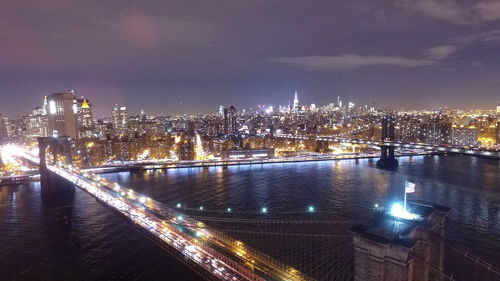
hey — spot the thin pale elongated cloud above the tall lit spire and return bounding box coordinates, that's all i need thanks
[271,54,436,71]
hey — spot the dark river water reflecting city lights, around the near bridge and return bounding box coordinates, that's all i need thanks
[0,156,500,280]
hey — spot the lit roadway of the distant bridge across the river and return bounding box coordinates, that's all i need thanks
[275,134,500,158]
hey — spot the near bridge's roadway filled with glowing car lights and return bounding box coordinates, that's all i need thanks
[8,145,313,281]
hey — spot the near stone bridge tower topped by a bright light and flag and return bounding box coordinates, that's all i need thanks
[351,201,450,281]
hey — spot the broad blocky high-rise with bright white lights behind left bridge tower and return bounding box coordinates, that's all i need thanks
[43,90,78,138]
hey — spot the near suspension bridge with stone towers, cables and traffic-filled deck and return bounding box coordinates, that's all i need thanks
[1,138,500,281]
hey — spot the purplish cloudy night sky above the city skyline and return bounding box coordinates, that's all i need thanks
[0,0,500,116]
